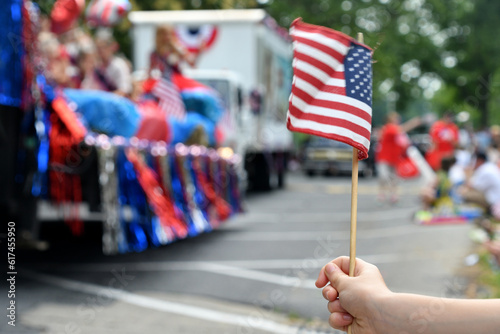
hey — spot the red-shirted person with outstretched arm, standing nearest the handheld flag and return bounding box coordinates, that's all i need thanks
[375,112,421,204]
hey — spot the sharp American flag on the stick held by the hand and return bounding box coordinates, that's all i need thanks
[287,19,372,159]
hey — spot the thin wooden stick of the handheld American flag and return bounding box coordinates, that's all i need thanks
[347,32,364,334]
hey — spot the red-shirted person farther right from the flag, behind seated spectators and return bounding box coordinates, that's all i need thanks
[425,112,459,171]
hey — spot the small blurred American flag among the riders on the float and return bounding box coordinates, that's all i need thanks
[152,75,186,119]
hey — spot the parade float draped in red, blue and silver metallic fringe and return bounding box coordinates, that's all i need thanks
[0,0,242,254]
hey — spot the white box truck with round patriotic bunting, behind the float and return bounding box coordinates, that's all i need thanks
[129,9,293,190]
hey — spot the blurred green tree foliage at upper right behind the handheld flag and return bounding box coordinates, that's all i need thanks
[268,0,500,125]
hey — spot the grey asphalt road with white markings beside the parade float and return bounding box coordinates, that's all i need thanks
[0,175,471,334]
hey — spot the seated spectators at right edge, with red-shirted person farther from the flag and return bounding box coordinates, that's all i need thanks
[422,113,500,265]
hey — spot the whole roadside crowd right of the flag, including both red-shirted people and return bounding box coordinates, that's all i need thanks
[375,112,500,265]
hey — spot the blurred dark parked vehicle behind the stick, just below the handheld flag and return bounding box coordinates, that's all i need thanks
[302,136,374,177]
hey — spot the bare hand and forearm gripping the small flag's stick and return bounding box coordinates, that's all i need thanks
[316,257,500,334]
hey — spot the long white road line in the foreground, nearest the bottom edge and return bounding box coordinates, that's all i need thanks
[29,272,299,334]
